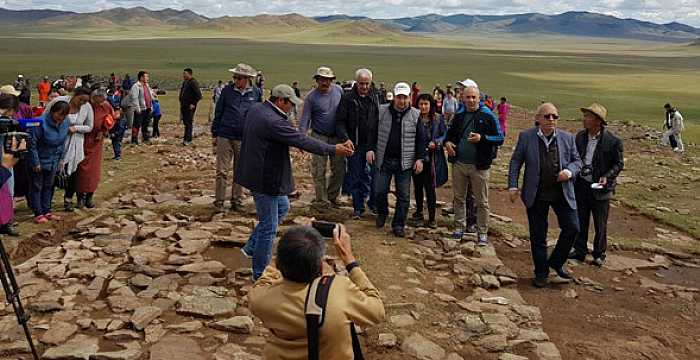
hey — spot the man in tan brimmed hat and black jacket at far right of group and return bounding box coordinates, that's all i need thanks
[569,103,625,266]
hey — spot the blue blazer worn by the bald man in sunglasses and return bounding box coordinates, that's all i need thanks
[508,127,582,209]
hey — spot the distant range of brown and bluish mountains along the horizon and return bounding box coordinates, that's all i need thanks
[0,7,700,42]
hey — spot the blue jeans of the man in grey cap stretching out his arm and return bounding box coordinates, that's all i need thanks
[243,193,289,280]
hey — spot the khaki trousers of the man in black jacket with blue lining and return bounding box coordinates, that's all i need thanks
[452,162,489,234]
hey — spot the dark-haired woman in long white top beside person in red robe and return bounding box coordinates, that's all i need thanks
[45,87,94,212]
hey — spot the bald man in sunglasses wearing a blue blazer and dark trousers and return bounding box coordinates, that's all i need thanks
[508,103,581,287]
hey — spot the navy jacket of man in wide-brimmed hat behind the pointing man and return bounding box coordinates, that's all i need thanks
[211,85,262,140]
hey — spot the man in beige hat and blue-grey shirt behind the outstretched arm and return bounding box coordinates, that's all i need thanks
[299,66,345,210]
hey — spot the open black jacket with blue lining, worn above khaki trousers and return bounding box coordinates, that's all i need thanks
[445,104,503,170]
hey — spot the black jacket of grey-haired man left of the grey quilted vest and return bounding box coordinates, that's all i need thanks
[335,85,380,146]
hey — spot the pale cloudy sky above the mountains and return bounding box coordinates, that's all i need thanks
[0,0,700,27]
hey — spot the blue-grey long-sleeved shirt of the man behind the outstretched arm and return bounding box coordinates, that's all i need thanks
[299,85,343,136]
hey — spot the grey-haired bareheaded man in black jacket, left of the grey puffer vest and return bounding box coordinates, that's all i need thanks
[335,69,379,219]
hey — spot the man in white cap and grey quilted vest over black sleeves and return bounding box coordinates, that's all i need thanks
[367,82,428,237]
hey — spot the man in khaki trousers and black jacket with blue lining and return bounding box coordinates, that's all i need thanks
[445,79,503,246]
